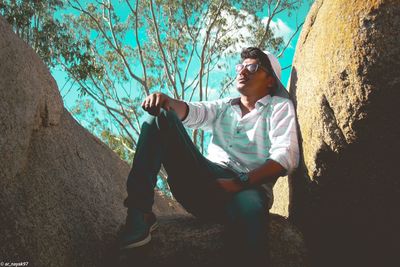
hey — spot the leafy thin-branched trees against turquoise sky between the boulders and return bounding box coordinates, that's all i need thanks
[0,0,309,193]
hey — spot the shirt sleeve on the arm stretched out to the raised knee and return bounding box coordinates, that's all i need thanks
[182,100,222,130]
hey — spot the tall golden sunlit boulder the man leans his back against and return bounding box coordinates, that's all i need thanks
[289,0,400,266]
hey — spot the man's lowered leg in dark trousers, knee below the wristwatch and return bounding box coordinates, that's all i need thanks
[225,188,269,266]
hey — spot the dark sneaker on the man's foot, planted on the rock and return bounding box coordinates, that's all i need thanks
[120,209,158,249]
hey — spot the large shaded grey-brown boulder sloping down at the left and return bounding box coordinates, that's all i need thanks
[0,17,182,266]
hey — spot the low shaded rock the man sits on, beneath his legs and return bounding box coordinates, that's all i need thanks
[119,214,308,267]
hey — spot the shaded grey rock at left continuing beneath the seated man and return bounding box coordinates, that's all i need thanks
[0,17,307,267]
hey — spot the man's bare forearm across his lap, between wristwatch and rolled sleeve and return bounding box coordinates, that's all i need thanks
[248,160,286,185]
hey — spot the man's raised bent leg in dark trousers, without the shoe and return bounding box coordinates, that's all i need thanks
[126,110,234,218]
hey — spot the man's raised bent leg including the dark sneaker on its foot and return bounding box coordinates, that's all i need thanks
[120,110,225,248]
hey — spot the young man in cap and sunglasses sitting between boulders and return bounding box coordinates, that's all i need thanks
[121,47,299,266]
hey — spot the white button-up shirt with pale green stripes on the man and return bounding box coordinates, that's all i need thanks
[182,95,299,205]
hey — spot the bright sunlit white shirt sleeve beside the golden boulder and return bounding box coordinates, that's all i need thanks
[269,100,299,175]
